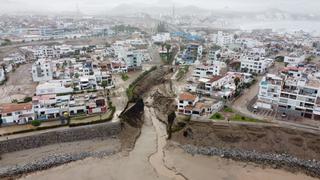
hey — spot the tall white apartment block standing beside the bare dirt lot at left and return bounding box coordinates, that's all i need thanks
[32,59,53,82]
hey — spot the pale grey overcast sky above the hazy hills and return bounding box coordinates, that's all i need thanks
[0,0,320,14]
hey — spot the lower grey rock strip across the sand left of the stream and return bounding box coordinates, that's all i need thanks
[0,150,116,178]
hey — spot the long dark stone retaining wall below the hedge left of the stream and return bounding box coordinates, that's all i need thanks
[0,122,121,154]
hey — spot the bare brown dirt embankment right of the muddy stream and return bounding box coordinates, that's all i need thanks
[173,122,320,160]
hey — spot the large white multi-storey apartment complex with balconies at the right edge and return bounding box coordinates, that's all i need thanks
[256,68,320,120]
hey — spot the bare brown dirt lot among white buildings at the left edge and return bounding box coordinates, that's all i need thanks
[0,64,37,103]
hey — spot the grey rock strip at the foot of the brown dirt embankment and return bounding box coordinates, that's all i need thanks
[180,145,320,177]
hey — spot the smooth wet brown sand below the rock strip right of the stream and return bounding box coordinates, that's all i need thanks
[166,148,316,180]
